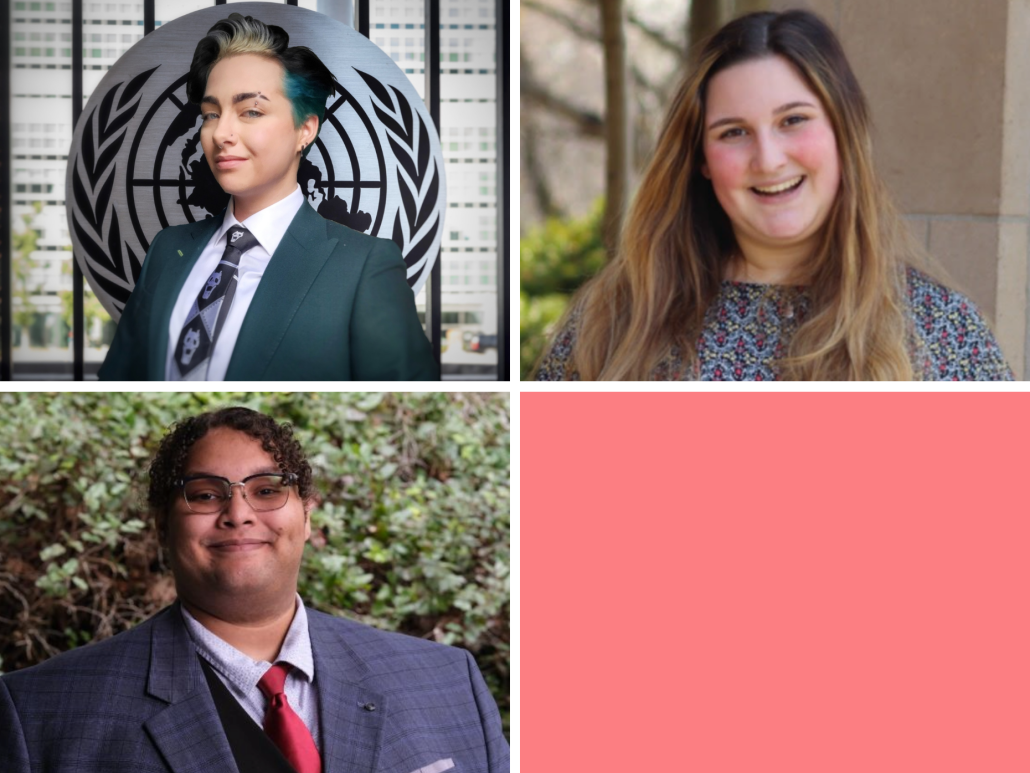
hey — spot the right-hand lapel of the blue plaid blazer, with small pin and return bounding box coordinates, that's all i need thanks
[308,614,389,773]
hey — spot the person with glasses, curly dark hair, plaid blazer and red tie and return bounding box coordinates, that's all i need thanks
[0,408,509,773]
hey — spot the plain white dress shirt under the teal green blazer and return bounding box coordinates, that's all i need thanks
[165,184,305,381]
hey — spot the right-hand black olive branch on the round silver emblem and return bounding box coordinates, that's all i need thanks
[354,67,440,285]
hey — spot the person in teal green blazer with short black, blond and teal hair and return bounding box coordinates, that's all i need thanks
[99,13,438,381]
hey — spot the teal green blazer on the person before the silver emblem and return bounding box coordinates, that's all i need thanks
[99,203,439,381]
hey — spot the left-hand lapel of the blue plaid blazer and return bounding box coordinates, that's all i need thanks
[144,602,239,773]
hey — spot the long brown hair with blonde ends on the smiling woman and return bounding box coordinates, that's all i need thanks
[552,10,923,380]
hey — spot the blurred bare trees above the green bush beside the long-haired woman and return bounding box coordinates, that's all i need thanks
[519,0,768,227]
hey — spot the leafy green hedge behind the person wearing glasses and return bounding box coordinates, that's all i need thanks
[0,393,510,733]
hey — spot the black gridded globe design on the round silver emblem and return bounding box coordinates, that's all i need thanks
[127,75,386,248]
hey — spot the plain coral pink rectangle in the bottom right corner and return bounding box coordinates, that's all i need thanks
[519,393,1030,773]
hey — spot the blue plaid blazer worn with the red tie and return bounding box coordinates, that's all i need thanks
[0,603,509,773]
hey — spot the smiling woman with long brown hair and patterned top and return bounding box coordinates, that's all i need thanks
[536,11,1011,380]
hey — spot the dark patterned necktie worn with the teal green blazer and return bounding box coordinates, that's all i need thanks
[175,226,259,381]
